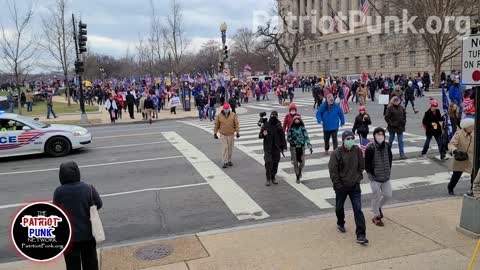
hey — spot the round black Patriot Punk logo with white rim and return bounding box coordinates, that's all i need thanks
[11,202,72,262]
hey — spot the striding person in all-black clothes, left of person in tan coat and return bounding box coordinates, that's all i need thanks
[422,99,445,160]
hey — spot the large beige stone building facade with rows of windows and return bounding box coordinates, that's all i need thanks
[280,0,461,76]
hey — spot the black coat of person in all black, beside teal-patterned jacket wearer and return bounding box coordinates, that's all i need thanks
[258,119,287,154]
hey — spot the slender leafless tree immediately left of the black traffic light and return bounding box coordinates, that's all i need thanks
[41,0,75,106]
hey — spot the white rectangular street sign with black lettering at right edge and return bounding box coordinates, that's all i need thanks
[462,35,480,85]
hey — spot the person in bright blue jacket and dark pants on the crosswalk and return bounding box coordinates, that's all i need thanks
[317,94,345,155]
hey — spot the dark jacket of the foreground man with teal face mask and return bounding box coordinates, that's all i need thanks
[328,145,365,190]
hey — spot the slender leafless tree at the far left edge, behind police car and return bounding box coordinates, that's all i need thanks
[0,0,39,114]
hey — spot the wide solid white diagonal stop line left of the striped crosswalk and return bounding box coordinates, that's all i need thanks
[163,132,269,220]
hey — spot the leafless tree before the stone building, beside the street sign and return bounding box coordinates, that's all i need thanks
[389,0,478,83]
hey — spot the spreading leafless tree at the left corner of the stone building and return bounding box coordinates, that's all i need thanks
[257,0,315,70]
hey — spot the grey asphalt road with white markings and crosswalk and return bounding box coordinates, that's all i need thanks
[0,90,469,262]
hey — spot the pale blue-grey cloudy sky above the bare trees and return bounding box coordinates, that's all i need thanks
[0,0,272,57]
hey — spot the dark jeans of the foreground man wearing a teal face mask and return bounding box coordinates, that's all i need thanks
[335,184,366,237]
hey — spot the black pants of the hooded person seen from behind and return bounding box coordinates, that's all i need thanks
[64,240,98,270]
